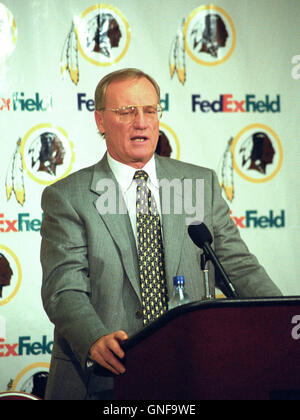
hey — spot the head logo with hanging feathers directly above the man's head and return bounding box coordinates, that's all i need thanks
[60,4,130,85]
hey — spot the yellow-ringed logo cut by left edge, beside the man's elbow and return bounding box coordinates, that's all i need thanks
[0,245,22,306]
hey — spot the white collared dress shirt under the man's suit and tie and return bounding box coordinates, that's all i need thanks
[107,153,162,241]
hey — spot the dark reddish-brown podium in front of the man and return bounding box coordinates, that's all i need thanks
[114,297,300,400]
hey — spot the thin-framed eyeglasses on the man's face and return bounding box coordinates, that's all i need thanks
[98,105,162,123]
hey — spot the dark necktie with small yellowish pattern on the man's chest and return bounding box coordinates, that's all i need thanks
[134,170,168,326]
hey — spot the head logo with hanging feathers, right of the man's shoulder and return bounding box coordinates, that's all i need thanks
[218,124,283,202]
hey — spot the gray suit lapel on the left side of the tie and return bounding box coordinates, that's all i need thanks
[91,154,141,300]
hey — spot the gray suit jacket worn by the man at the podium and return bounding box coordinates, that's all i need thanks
[41,155,281,399]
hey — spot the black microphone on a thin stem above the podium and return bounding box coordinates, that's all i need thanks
[188,222,238,298]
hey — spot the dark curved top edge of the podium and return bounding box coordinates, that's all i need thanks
[122,296,300,351]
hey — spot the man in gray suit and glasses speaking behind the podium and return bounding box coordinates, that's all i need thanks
[41,69,280,399]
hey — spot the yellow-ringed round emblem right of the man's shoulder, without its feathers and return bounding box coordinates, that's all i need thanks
[231,124,283,183]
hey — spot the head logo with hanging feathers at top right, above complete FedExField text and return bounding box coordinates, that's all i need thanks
[169,5,236,84]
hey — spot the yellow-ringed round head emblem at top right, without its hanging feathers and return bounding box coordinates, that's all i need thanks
[183,5,236,66]
